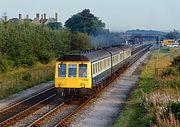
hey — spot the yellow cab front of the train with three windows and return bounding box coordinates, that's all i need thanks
[55,61,92,98]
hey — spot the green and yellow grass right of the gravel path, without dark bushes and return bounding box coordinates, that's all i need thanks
[114,47,180,127]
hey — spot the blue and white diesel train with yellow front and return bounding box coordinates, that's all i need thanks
[55,46,149,97]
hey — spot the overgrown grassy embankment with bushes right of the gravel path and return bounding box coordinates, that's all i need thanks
[114,47,180,127]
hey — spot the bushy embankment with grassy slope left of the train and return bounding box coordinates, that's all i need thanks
[0,21,90,99]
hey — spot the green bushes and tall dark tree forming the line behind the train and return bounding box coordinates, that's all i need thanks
[0,9,105,72]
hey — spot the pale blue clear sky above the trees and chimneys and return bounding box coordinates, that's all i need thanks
[0,0,180,31]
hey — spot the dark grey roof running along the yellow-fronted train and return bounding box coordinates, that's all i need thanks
[57,46,129,62]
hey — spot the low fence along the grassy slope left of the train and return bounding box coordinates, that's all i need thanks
[0,66,54,98]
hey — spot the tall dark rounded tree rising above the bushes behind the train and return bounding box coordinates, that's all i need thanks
[65,9,105,35]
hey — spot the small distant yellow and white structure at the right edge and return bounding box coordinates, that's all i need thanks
[161,39,179,48]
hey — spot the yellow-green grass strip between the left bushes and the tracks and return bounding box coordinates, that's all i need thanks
[0,61,55,99]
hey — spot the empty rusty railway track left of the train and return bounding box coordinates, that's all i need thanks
[0,88,55,126]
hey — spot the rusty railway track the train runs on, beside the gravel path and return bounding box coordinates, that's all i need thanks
[20,46,150,127]
